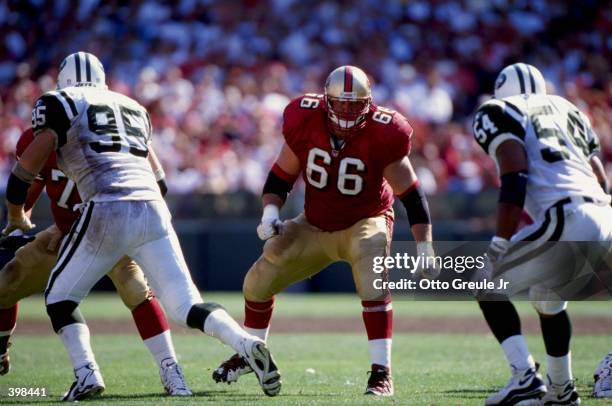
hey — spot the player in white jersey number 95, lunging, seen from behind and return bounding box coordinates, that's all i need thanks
[6,52,281,400]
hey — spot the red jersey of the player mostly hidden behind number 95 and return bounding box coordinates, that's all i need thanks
[17,128,81,233]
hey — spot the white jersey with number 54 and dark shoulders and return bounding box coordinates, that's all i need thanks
[474,94,610,219]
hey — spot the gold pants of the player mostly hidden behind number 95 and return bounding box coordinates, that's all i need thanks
[0,226,151,310]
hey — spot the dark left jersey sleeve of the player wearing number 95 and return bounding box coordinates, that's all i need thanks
[32,92,77,149]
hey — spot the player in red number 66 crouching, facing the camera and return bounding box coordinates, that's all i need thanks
[213,66,432,396]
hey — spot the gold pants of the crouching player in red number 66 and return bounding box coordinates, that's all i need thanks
[243,210,393,302]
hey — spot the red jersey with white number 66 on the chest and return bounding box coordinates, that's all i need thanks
[283,94,412,231]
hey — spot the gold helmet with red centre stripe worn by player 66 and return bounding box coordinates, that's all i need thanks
[325,65,372,137]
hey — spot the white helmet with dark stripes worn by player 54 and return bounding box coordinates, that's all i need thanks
[495,63,546,99]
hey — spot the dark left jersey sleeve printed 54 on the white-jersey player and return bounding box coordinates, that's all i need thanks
[473,100,527,160]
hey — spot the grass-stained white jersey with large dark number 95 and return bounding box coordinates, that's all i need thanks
[32,87,162,202]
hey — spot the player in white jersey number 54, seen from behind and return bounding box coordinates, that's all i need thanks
[474,63,612,405]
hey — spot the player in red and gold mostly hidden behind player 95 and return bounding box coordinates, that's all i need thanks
[0,129,191,396]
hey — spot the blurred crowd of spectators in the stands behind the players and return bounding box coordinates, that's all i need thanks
[0,0,612,194]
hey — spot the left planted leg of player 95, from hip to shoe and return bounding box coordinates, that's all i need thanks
[45,202,129,400]
